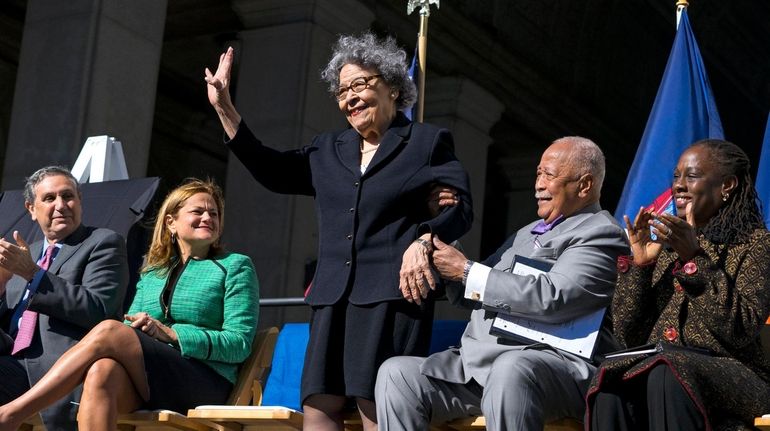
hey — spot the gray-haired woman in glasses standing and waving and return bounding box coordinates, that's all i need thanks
[206,33,472,430]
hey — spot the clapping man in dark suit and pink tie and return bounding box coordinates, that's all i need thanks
[0,166,128,430]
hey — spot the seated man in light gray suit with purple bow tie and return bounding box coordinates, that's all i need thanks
[375,137,629,431]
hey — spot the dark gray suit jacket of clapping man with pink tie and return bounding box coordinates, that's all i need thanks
[0,225,128,430]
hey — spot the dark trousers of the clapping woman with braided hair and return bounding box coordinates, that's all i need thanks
[590,364,706,431]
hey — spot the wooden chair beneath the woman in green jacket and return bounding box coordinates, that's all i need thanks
[118,327,278,431]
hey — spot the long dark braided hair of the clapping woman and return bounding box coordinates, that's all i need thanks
[692,139,765,244]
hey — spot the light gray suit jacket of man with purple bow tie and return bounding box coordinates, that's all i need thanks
[421,204,629,386]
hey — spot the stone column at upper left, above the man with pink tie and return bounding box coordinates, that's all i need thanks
[2,0,166,188]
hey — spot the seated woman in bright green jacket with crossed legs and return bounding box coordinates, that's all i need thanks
[0,180,259,430]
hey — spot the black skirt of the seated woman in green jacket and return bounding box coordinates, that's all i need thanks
[135,329,233,414]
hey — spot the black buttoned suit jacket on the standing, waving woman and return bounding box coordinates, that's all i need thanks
[227,113,473,305]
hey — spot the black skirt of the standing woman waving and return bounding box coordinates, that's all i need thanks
[300,298,433,404]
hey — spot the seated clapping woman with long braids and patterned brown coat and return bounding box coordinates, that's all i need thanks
[586,139,770,430]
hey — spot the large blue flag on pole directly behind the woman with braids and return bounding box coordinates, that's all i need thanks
[615,10,724,224]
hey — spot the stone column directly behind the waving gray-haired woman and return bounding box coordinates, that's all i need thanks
[225,0,374,322]
